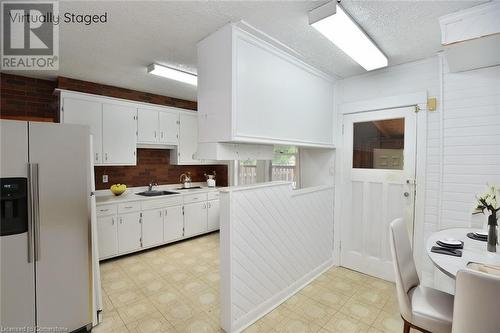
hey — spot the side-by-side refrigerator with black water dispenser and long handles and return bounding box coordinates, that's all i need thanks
[0,120,92,332]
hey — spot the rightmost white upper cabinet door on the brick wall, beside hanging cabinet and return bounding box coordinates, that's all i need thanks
[178,113,198,164]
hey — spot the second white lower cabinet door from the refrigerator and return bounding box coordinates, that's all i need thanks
[118,212,141,253]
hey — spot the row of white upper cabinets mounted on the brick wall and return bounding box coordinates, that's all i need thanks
[60,90,209,165]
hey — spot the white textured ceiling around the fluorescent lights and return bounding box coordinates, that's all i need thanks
[2,0,484,100]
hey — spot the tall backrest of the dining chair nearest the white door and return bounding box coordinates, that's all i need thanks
[389,218,420,322]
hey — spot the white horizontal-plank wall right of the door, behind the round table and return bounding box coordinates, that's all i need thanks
[435,61,500,291]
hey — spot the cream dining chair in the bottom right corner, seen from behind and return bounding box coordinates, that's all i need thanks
[452,270,500,333]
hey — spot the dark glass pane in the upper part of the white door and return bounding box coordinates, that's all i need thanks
[352,118,405,170]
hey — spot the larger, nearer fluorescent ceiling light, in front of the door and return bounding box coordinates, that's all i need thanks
[309,1,387,71]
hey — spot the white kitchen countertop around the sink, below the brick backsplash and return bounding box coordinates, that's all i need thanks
[95,183,224,205]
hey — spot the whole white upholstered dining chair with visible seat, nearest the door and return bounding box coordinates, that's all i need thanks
[390,218,456,333]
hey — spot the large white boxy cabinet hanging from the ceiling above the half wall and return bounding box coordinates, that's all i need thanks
[198,23,334,148]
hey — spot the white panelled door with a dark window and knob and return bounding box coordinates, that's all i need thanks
[341,107,417,280]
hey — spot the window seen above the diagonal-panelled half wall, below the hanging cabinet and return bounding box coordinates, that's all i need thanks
[238,146,299,187]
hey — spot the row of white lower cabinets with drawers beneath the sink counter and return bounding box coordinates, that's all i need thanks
[97,192,220,259]
